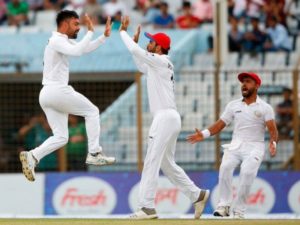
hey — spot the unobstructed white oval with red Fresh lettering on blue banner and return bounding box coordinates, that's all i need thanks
[52,176,117,215]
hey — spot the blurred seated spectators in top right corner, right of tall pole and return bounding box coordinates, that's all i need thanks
[228,0,298,53]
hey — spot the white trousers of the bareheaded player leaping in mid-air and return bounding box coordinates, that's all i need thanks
[32,85,101,161]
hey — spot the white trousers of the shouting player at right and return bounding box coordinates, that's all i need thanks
[218,142,265,214]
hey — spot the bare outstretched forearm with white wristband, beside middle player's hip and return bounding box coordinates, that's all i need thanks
[186,119,226,144]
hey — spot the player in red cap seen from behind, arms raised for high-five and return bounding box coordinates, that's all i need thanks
[120,17,209,219]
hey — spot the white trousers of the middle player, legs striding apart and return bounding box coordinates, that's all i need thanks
[139,109,200,208]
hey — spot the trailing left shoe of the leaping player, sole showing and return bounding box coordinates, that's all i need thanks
[19,151,37,181]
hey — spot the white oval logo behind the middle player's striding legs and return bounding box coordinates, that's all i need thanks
[128,176,191,214]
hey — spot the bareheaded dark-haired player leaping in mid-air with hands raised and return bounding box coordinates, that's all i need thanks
[20,10,115,181]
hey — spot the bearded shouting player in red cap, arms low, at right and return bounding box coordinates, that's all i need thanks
[187,72,278,219]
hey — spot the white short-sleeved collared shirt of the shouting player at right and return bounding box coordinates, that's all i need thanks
[221,96,275,142]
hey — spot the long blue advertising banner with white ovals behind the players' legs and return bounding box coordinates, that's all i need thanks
[44,172,300,216]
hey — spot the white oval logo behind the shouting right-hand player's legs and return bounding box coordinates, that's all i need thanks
[211,177,275,214]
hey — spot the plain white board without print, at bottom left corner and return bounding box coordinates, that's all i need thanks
[0,174,45,216]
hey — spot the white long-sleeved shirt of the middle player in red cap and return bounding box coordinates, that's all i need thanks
[120,31,176,115]
